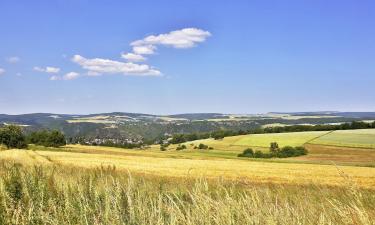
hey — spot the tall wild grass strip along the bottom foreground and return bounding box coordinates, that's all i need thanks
[0,163,375,224]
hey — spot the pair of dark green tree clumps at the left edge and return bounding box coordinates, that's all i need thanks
[0,125,66,149]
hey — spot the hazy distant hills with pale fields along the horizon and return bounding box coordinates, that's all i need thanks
[0,111,375,143]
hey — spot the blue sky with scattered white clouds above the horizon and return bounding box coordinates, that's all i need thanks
[0,0,375,114]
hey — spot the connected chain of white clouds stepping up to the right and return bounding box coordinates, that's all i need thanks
[72,28,211,76]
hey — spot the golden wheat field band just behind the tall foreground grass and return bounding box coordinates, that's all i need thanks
[0,145,375,188]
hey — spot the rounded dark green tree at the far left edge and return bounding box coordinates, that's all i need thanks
[0,125,27,149]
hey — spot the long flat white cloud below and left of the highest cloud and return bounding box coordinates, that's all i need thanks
[72,55,162,76]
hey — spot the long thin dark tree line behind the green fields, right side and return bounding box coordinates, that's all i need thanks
[169,121,375,144]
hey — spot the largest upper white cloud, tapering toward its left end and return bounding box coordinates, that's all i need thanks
[130,28,211,48]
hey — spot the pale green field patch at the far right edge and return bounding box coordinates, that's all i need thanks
[310,129,375,148]
